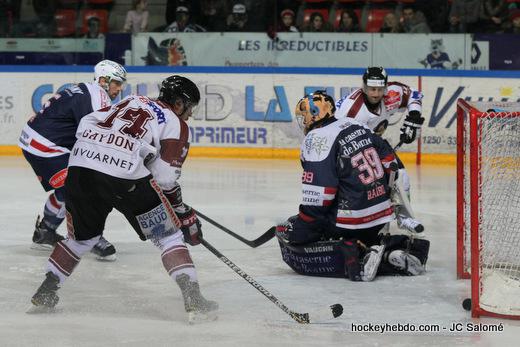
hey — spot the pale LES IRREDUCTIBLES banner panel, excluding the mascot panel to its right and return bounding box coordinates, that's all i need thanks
[132,33,372,67]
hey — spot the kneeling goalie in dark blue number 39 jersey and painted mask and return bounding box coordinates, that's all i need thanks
[277,92,429,281]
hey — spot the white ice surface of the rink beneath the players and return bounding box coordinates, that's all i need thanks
[0,157,520,347]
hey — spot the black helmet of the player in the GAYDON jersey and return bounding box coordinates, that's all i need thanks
[158,75,200,109]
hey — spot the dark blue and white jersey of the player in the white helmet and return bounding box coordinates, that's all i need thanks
[19,83,111,157]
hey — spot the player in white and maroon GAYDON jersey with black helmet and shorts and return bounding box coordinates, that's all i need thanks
[32,75,218,321]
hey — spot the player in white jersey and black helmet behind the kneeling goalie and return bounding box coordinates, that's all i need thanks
[335,67,424,231]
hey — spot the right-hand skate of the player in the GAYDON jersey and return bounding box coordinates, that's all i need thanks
[176,274,218,324]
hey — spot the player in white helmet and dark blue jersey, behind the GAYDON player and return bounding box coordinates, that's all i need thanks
[18,60,126,260]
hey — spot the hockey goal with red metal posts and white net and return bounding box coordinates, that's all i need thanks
[457,99,520,319]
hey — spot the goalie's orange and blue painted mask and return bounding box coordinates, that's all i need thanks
[295,91,336,135]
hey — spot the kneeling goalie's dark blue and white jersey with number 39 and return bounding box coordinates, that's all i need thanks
[300,118,395,229]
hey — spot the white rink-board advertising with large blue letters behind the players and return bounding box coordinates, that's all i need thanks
[0,70,520,153]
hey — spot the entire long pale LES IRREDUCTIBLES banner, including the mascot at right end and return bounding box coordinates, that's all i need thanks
[132,33,482,70]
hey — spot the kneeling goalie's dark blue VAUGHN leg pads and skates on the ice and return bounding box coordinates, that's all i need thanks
[276,217,430,281]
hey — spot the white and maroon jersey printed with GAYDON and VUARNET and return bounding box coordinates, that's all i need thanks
[69,96,189,188]
